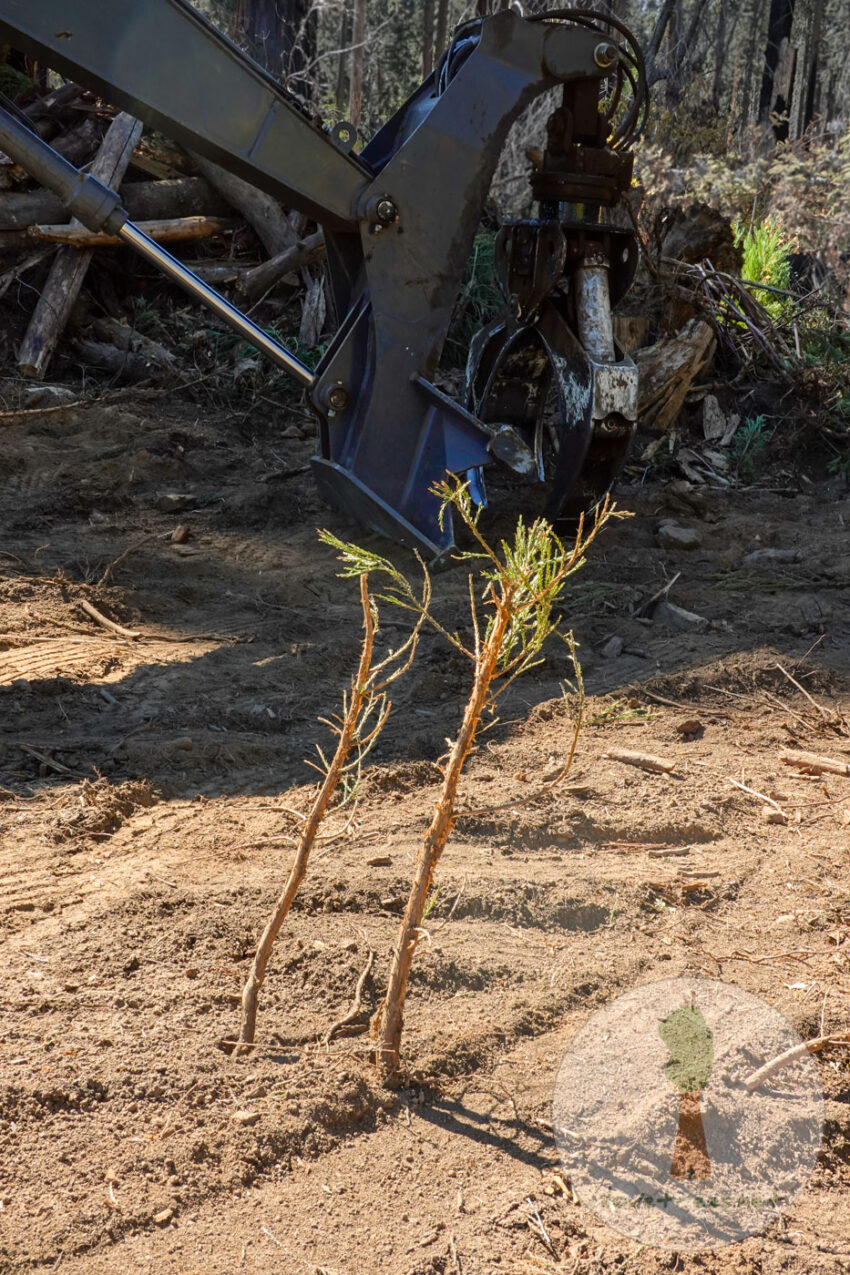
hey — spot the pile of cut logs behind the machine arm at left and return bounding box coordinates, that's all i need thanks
[0,83,325,380]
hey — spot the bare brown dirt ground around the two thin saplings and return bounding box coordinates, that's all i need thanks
[0,398,850,1275]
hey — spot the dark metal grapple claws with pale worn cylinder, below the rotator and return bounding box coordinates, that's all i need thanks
[465,222,637,521]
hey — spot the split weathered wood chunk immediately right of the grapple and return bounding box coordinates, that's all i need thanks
[635,319,716,431]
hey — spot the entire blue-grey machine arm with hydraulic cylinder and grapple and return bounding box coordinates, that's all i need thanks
[0,0,646,557]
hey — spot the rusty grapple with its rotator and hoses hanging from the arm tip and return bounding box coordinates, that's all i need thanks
[466,10,646,519]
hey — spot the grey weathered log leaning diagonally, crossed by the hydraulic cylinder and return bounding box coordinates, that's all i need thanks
[18,111,141,377]
